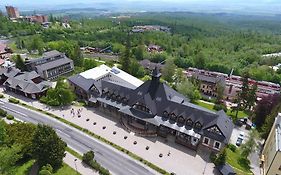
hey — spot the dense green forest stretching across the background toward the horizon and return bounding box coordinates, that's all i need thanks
[0,13,281,83]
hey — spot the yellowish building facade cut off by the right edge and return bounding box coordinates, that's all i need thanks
[261,113,281,175]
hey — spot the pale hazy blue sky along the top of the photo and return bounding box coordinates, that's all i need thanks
[0,0,281,14]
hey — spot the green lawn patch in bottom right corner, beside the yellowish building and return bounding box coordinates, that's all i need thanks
[225,148,253,175]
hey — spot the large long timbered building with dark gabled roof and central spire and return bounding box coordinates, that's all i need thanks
[69,65,234,151]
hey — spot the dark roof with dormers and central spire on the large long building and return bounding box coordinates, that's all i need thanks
[97,69,234,143]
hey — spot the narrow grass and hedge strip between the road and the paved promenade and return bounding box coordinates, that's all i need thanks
[19,102,169,175]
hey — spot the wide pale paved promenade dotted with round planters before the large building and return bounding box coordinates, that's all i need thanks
[0,89,215,175]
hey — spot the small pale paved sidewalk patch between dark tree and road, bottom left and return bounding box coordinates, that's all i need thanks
[63,152,99,175]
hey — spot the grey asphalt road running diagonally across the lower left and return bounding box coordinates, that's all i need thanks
[0,101,157,175]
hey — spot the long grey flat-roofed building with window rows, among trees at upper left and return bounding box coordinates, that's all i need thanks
[25,50,74,80]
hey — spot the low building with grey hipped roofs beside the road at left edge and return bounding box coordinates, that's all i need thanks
[0,67,51,99]
